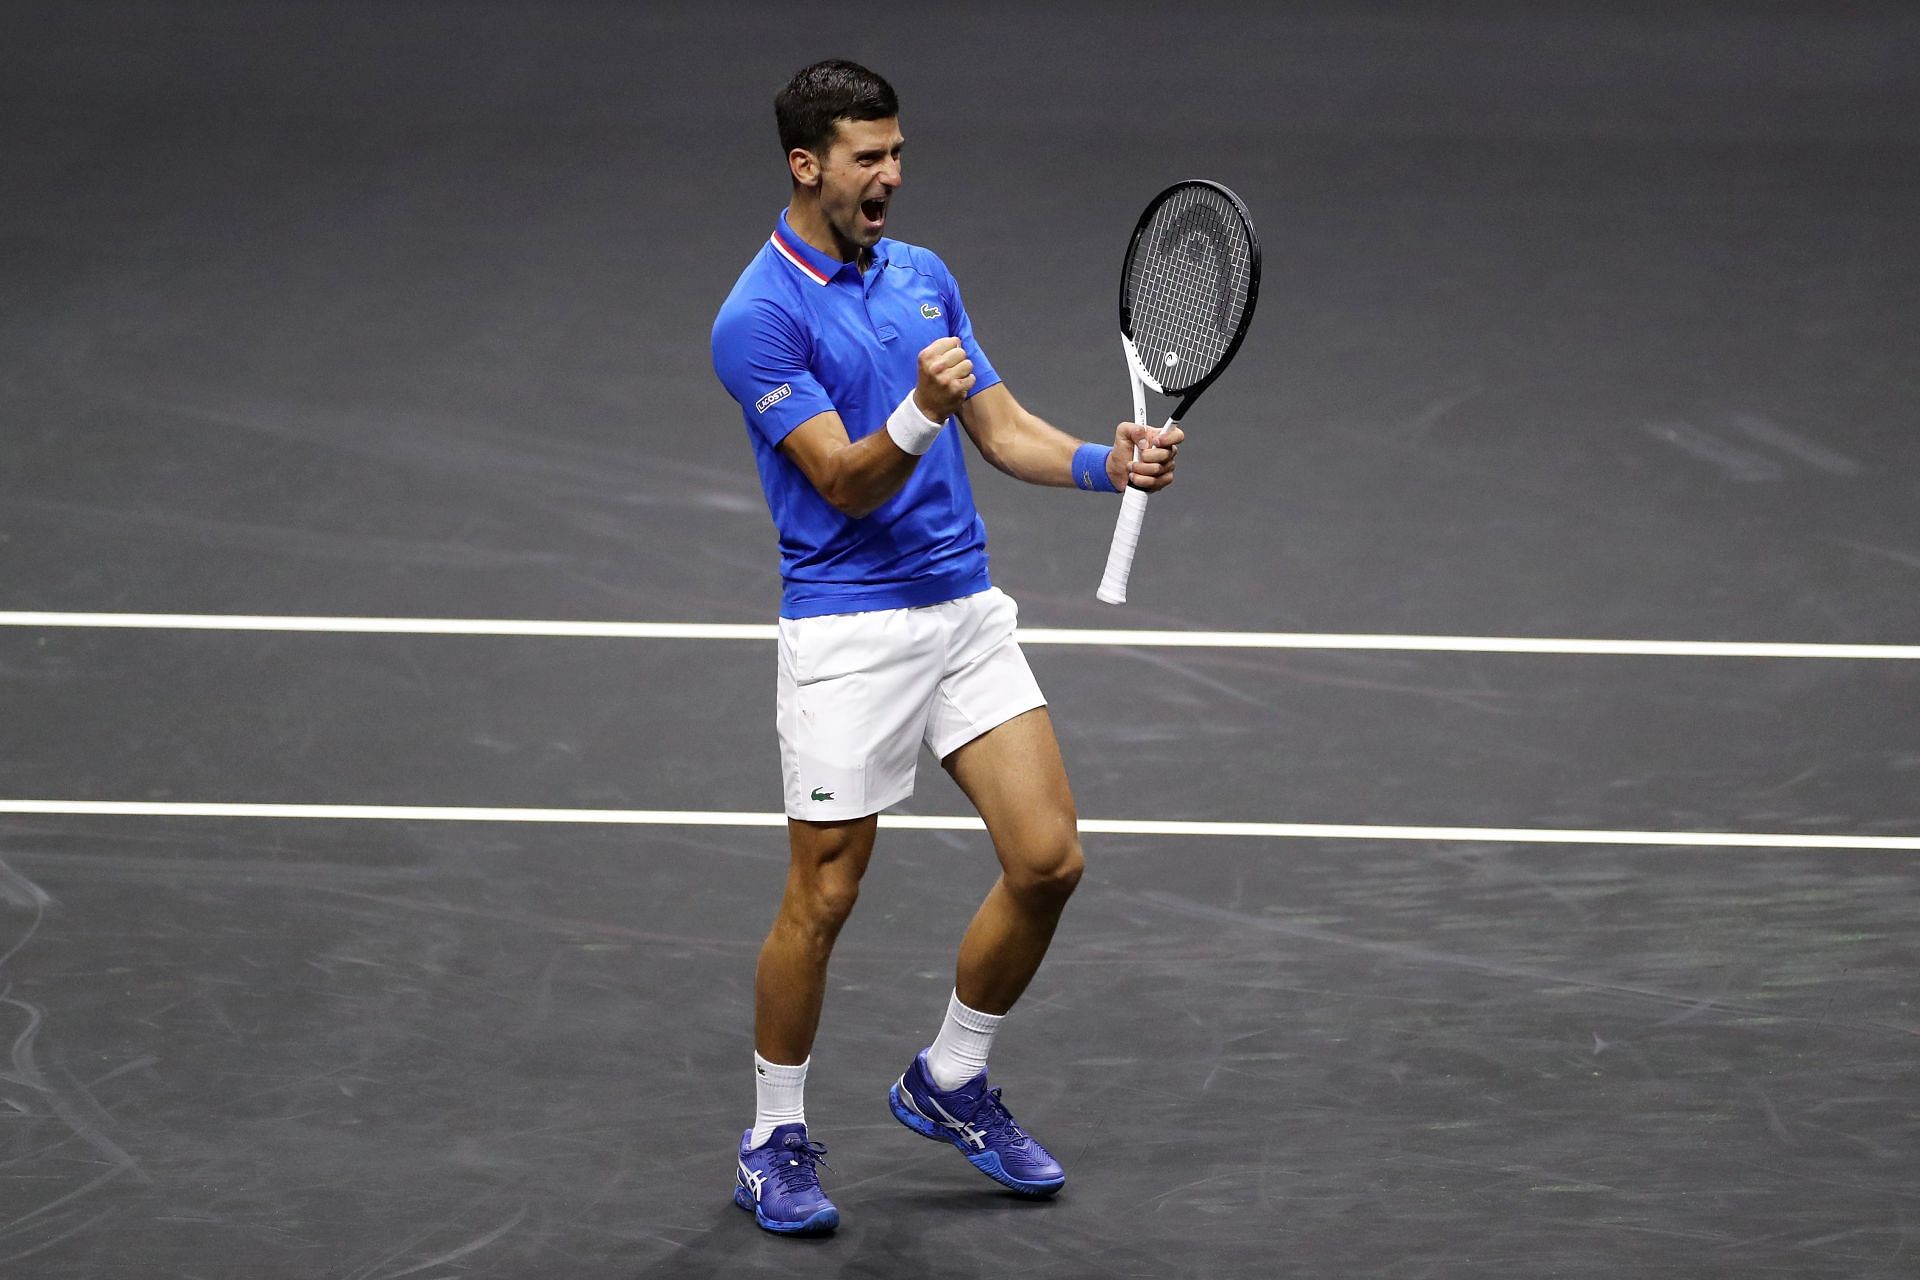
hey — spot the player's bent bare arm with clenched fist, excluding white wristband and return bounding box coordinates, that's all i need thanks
[780,338,973,520]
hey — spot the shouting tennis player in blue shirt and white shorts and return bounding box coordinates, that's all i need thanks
[712,59,1181,1234]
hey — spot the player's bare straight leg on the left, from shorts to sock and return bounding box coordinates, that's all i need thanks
[753,814,879,1065]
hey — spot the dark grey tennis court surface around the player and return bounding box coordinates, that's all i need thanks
[0,0,1920,1280]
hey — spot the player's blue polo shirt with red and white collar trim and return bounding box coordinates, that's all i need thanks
[712,209,1000,618]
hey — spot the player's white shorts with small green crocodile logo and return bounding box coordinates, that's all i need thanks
[776,587,1046,821]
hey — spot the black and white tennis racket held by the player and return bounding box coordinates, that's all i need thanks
[1096,178,1260,604]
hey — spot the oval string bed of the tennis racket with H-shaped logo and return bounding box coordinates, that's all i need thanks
[1127,184,1254,393]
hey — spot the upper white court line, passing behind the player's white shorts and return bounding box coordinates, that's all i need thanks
[0,612,1920,662]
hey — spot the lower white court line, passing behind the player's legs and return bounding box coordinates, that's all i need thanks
[0,800,1920,852]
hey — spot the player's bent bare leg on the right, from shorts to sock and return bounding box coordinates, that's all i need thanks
[941,706,1085,1015]
